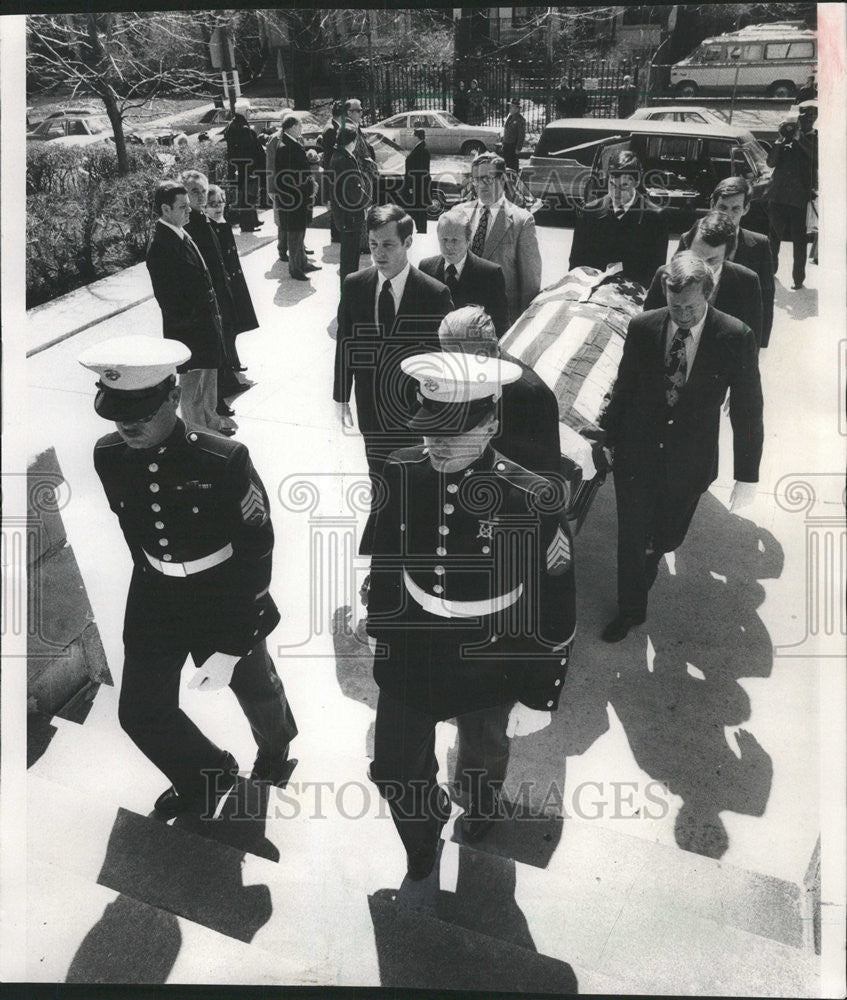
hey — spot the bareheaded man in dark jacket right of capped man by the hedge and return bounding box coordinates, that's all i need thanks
[271,114,320,281]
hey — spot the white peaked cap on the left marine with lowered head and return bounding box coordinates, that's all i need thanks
[79,336,191,420]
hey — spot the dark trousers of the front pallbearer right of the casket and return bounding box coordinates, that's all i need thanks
[615,472,702,618]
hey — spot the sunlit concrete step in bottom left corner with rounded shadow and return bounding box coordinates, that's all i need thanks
[26,859,301,986]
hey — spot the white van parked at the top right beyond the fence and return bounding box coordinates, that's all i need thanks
[670,21,818,97]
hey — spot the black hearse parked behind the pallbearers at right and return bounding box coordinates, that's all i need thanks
[521,118,771,226]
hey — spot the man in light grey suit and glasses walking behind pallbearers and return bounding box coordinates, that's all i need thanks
[457,153,541,323]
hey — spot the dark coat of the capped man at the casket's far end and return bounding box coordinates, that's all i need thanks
[568,195,668,288]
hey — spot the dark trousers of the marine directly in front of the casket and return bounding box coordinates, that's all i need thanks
[371,692,512,854]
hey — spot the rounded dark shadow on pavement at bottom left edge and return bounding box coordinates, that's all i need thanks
[65,896,182,983]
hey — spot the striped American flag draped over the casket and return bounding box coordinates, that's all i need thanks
[500,264,646,464]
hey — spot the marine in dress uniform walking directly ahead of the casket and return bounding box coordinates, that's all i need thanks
[367,354,575,880]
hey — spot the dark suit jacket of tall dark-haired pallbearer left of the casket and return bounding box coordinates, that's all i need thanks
[332,266,453,434]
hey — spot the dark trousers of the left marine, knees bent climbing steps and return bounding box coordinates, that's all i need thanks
[118,640,297,803]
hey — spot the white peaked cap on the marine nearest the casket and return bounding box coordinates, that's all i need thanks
[400,351,521,436]
